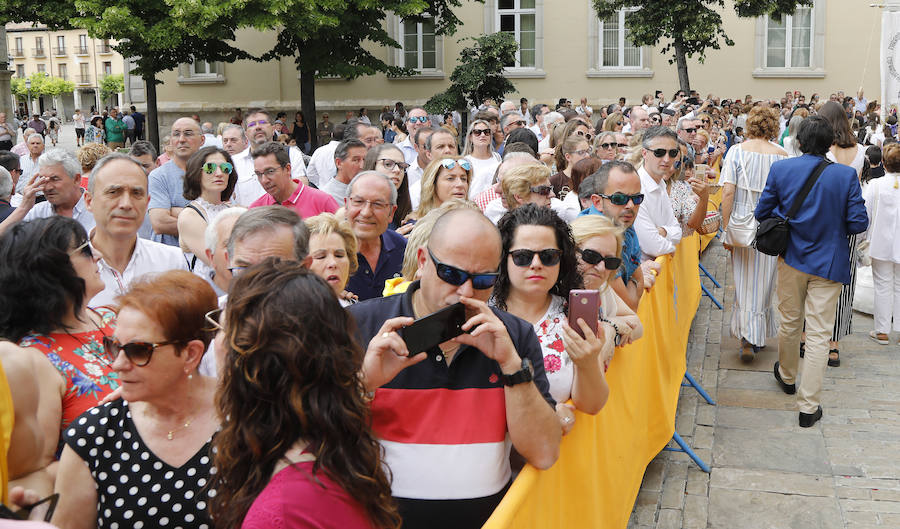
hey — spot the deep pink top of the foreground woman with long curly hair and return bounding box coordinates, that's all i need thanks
[241,461,373,529]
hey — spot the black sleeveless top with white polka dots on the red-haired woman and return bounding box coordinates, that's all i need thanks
[64,399,215,529]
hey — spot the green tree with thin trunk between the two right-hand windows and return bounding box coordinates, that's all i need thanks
[593,0,812,91]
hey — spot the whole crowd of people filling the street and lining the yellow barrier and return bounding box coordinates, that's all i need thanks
[0,84,884,528]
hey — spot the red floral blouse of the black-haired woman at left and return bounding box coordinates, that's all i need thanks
[19,309,119,429]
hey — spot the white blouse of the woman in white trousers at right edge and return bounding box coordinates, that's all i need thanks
[863,173,900,263]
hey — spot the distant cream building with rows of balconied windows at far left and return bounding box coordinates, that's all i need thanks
[6,23,124,119]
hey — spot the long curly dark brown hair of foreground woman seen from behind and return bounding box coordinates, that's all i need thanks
[210,258,400,529]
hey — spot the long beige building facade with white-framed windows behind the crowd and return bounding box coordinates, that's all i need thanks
[132,0,881,132]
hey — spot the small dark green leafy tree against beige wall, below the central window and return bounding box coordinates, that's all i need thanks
[425,32,519,114]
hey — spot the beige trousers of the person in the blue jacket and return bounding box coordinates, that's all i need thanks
[778,257,842,413]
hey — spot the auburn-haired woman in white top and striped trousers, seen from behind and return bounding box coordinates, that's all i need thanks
[719,107,787,362]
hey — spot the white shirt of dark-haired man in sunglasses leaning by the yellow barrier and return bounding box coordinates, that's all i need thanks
[634,167,681,260]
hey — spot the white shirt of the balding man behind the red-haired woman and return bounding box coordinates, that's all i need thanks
[88,233,188,307]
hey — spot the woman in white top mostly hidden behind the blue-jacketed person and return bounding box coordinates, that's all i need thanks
[819,101,866,367]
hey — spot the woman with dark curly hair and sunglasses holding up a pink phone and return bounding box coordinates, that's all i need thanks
[491,204,615,433]
